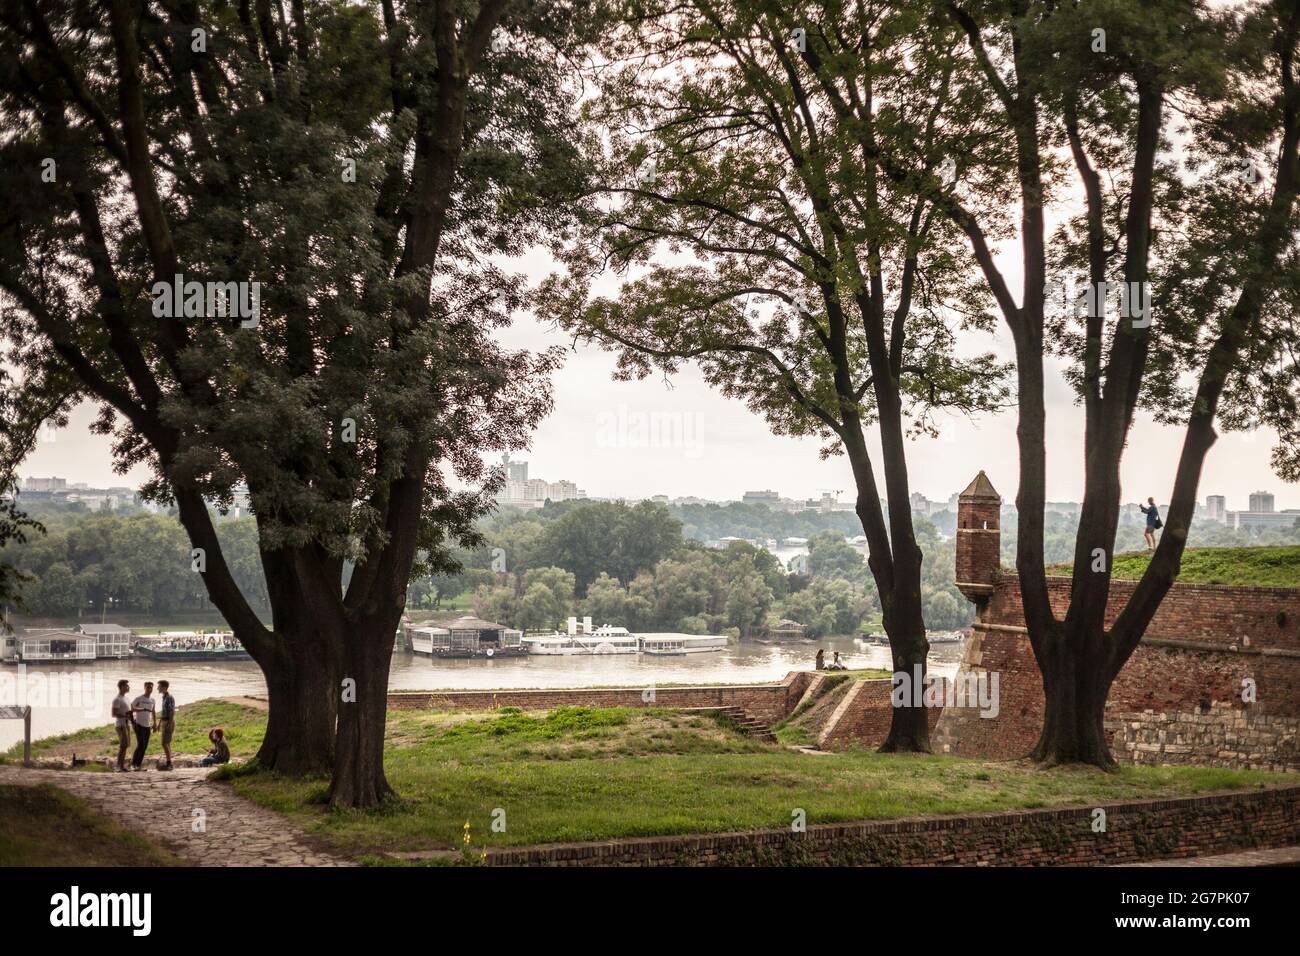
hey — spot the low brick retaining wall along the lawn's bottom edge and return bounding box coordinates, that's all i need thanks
[488,787,1300,866]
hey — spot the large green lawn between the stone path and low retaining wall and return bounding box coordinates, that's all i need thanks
[218,708,1291,862]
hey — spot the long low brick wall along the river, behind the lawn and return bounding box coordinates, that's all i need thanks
[389,671,813,723]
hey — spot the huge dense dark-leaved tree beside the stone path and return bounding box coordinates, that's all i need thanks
[0,0,581,805]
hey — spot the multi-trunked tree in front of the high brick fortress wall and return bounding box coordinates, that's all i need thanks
[909,0,1300,766]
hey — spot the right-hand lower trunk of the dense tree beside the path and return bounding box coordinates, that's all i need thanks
[329,614,398,808]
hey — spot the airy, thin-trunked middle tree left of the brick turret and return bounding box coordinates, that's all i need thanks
[551,0,1004,750]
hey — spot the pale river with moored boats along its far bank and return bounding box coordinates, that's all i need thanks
[0,637,962,750]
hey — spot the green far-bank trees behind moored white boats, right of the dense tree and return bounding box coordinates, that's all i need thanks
[410,501,974,637]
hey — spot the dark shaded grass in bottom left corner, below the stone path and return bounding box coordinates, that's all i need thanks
[0,784,179,866]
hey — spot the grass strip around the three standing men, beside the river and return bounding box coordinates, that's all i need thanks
[0,700,267,762]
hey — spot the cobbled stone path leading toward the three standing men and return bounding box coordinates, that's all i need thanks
[0,765,352,866]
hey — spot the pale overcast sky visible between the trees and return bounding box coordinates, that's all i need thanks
[20,227,1300,510]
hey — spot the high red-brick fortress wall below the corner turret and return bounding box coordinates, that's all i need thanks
[933,574,1300,770]
